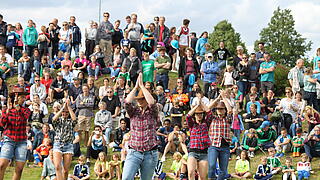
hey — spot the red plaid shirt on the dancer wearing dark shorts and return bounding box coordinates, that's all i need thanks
[186,111,213,150]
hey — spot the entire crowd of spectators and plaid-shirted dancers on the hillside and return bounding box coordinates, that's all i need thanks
[0,12,320,180]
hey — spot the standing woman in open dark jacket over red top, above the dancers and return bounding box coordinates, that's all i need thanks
[179,48,200,92]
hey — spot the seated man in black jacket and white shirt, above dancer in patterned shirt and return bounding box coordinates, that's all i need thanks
[49,72,69,103]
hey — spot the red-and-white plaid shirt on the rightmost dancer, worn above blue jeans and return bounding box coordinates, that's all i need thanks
[209,115,232,147]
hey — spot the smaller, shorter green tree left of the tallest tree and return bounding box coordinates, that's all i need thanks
[209,20,247,54]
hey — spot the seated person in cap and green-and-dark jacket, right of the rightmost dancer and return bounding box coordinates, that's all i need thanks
[257,121,276,150]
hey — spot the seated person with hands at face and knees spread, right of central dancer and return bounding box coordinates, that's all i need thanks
[161,124,188,161]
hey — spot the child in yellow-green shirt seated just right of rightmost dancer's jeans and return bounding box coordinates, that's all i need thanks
[231,150,251,179]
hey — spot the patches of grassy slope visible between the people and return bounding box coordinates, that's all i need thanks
[5,73,320,180]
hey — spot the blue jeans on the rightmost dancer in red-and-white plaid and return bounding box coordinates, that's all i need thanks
[208,146,230,180]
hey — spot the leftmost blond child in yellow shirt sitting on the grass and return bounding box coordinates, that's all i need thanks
[94,152,110,180]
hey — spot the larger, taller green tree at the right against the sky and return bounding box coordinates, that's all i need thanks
[255,7,312,67]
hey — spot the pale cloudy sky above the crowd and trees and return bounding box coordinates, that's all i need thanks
[0,0,320,58]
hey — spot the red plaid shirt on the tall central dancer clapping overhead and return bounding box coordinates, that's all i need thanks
[125,102,158,152]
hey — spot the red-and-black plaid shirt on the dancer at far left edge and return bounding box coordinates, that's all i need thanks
[0,107,31,142]
